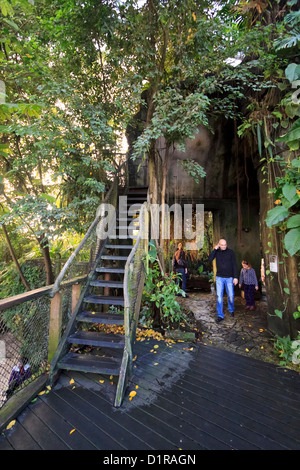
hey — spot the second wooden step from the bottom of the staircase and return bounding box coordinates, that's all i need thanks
[68,331,125,348]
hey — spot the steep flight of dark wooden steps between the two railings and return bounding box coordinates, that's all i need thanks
[49,188,147,404]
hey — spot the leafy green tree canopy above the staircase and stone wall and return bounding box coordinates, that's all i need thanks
[0,0,300,283]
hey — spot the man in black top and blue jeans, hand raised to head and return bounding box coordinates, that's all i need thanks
[208,238,238,323]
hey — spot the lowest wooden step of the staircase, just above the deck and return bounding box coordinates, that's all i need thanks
[58,353,121,375]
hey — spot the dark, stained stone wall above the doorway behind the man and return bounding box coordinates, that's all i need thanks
[157,121,261,276]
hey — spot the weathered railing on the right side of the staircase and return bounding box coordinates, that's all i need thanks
[114,196,149,407]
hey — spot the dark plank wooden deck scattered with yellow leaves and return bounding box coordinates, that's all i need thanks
[0,339,300,452]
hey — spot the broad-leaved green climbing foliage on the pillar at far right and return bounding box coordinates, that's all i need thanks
[238,4,300,256]
